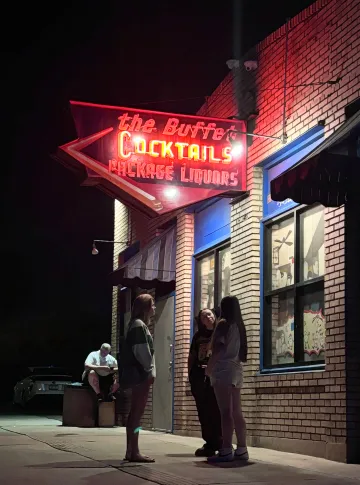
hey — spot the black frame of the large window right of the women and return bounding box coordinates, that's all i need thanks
[260,204,326,374]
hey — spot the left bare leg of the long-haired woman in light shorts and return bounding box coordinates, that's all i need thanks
[214,382,234,454]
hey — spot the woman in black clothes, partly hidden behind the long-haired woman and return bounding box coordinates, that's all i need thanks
[188,308,222,457]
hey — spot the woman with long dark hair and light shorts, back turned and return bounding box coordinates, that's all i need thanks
[206,296,249,462]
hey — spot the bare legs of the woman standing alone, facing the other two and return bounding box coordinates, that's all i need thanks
[125,380,153,462]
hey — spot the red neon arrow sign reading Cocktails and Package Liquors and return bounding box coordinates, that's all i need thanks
[60,102,246,214]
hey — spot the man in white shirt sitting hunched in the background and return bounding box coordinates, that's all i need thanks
[82,344,119,402]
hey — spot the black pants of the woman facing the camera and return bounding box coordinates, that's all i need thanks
[190,368,222,451]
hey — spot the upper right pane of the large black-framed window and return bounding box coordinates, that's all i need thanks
[300,206,325,281]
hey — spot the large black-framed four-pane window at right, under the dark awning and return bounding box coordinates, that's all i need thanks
[263,205,325,369]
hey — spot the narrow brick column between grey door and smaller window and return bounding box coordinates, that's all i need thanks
[174,213,194,433]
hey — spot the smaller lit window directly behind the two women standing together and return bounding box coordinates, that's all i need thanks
[194,245,231,315]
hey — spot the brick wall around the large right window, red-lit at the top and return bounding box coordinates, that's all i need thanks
[200,0,360,461]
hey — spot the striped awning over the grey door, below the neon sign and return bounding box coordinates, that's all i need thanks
[110,226,176,292]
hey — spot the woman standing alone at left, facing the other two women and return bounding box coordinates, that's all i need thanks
[121,294,156,463]
